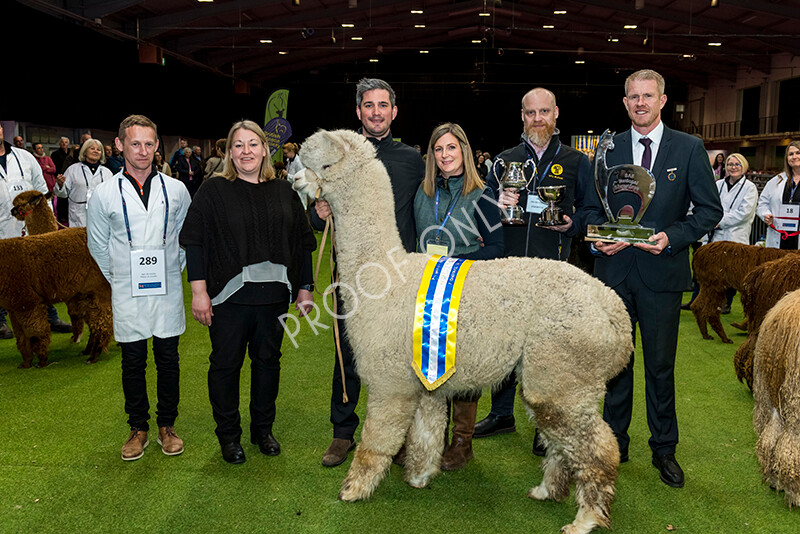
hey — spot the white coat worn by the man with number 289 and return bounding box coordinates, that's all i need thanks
[86,173,191,343]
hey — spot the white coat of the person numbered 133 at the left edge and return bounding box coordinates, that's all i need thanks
[0,144,47,239]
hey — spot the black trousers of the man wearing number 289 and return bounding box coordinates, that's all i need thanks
[120,336,180,430]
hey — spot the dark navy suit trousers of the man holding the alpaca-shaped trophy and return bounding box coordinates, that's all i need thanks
[603,266,682,455]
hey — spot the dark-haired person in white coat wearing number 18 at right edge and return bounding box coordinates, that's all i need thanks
[756,140,800,250]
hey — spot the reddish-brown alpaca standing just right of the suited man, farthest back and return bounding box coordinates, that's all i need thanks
[692,241,797,343]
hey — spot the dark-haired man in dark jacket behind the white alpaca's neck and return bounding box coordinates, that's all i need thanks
[311,78,425,467]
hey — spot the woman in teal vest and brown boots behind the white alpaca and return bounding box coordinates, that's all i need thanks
[414,123,503,471]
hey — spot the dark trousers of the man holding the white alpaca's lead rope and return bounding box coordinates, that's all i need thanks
[331,288,361,439]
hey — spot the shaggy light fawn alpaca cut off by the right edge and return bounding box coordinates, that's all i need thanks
[753,291,800,508]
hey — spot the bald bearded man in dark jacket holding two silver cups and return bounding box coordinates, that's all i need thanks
[474,87,591,456]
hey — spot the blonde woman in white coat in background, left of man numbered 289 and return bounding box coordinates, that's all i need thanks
[53,139,113,228]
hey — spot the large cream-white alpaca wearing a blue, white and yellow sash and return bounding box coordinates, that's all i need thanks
[296,130,633,533]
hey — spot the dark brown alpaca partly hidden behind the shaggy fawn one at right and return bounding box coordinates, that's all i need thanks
[733,254,800,389]
